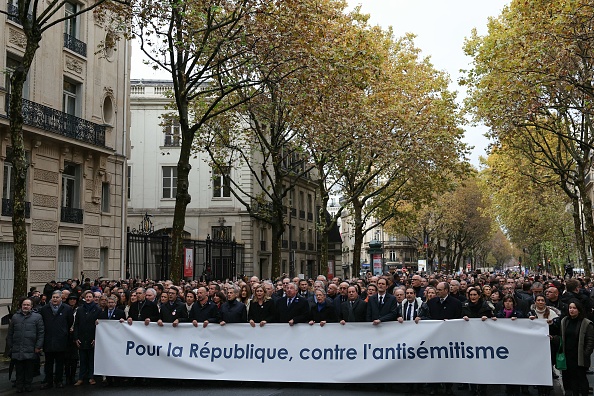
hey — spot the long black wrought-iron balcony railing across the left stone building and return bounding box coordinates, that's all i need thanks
[6,95,105,147]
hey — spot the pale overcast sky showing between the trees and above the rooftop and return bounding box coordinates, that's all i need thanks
[131,0,509,168]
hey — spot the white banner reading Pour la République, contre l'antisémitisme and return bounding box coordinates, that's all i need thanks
[95,319,552,385]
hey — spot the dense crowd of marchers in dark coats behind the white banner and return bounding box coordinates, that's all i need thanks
[8,273,594,396]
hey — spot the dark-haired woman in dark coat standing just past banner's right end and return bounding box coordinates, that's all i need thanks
[551,300,594,396]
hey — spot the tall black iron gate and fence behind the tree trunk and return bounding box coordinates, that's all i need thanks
[126,232,244,280]
